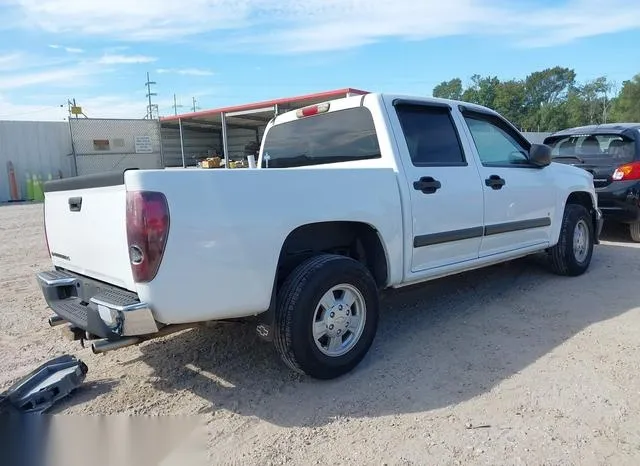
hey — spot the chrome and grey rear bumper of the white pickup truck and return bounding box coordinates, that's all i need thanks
[37,270,159,339]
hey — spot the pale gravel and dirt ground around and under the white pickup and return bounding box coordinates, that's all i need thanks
[0,205,640,465]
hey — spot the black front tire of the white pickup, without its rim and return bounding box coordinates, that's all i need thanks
[549,204,595,277]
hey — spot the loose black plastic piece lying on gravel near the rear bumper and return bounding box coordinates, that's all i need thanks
[0,355,88,414]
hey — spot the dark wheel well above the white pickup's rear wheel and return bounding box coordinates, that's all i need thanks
[277,222,388,288]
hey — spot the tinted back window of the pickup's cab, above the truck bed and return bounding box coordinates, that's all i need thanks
[262,107,380,168]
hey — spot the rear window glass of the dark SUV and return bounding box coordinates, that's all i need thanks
[547,134,635,163]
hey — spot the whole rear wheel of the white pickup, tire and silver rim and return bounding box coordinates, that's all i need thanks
[274,254,378,379]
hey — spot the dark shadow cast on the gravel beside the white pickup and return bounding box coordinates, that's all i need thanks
[135,238,640,426]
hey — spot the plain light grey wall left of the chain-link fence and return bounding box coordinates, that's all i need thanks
[0,121,73,202]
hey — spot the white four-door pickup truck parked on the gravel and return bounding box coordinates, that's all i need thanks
[38,94,602,379]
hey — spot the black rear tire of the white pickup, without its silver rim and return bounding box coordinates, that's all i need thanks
[274,254,379,379]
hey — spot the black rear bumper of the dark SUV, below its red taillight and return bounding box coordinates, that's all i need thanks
[596,181,640,223]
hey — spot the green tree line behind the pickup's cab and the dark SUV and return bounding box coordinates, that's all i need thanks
[433,66,640,131]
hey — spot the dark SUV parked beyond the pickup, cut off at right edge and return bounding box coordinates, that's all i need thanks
[544,123,640,242]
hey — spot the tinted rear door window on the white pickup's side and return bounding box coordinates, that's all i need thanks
[396,104,466,166]
